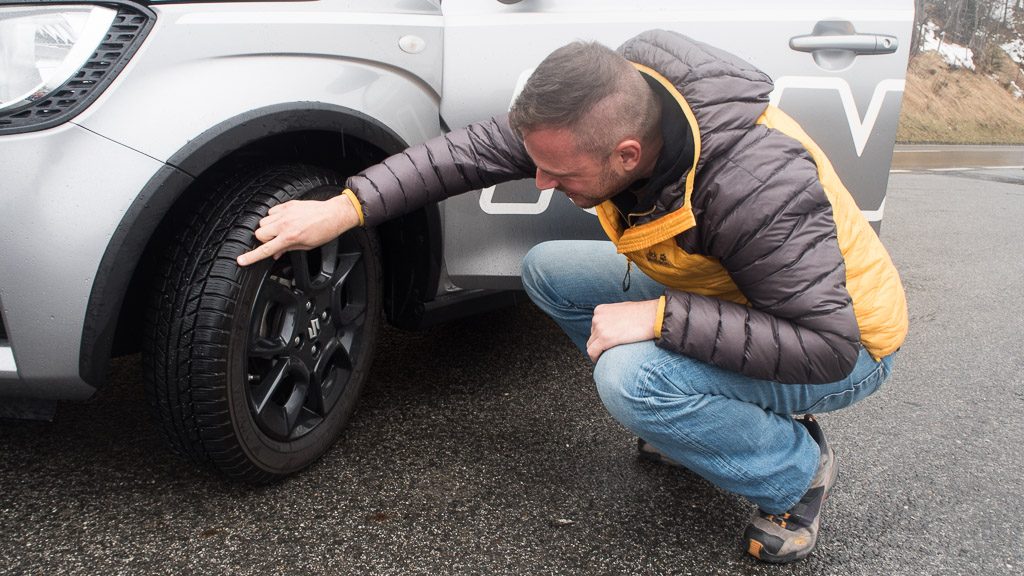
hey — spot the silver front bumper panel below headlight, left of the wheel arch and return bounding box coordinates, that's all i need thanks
[0,124,164,399]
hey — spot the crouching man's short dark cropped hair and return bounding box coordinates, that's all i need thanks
[509,42,660,155]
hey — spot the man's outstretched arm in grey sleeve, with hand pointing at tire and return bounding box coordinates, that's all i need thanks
[238,116,536,265]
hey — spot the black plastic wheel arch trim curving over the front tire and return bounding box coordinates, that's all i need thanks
[79,102,428,388]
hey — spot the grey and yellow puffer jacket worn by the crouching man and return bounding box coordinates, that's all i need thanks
[346,31,907,383]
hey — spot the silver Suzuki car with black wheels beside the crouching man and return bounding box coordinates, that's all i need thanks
[0,0,913,483]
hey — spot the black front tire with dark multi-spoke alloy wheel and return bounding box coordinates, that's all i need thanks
[142,165,382,483]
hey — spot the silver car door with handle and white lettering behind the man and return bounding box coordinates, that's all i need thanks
[441,0,913,288]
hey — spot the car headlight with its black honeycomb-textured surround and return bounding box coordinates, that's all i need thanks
[0,1,154,134]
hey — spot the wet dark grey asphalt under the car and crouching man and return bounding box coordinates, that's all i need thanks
[0,163,1024,576]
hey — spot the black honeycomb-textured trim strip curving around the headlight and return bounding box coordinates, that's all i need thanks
[0,1,156,135]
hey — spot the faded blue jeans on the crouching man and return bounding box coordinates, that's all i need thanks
[522,241,892,513]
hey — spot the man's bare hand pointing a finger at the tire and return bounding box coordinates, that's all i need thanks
[238,195,359,266]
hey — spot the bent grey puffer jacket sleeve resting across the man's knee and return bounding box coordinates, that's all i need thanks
[657,138,860,383]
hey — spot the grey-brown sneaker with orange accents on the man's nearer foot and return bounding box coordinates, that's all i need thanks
[743,415,839,564]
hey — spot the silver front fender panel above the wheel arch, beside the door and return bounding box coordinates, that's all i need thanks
[74,0,442,168]
